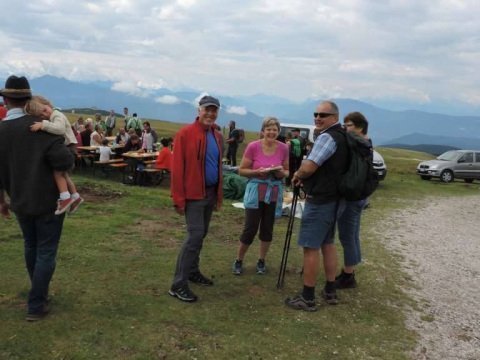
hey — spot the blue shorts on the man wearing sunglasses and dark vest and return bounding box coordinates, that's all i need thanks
[298,201,344,249]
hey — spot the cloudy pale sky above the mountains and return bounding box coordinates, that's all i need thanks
[0,0,480,114]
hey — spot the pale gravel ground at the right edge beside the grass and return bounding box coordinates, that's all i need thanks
[384,196,480,360]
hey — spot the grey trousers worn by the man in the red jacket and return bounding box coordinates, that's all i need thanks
[172,187,217,288]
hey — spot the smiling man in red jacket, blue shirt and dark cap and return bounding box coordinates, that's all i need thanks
[168,96,223,302]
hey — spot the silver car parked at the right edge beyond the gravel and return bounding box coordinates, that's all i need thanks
[417,150,480,183]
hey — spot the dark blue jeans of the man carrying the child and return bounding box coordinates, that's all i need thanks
[17,213,65,314]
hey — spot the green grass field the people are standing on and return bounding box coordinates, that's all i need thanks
[0,125,479,359]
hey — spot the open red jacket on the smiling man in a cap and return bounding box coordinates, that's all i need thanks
[170,117,223,209]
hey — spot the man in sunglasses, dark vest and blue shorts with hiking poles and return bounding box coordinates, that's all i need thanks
[285,101,348,311]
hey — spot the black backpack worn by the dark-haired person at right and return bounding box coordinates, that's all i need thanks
[338,132,378,201]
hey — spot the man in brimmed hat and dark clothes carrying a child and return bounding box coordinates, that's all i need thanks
[0,75,74,321]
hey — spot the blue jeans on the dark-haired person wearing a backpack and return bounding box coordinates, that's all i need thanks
[338,199,367,266]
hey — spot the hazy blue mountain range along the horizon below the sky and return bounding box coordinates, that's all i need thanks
[31,75,480,149]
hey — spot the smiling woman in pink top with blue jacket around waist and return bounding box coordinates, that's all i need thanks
[232,117,288,275]
